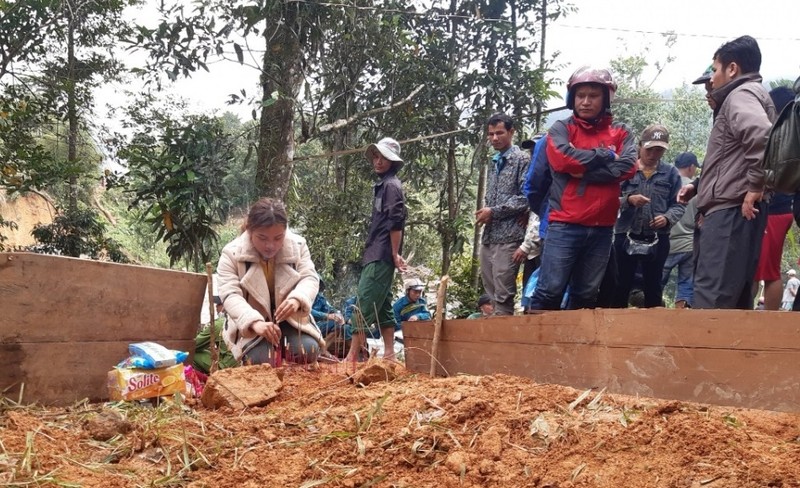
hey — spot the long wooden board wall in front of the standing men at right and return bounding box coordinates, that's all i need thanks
[403,309,800,412]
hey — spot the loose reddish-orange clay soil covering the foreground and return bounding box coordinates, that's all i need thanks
[0,360,800,488]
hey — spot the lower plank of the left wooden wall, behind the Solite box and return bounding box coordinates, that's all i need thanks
[0,339,194,405]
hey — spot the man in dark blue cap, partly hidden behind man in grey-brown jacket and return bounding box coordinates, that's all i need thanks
[661,152,700,308]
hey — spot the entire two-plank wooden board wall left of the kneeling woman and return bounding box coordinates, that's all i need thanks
[0,253,206,405]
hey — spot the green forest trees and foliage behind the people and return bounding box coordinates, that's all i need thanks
[0,0,798,316]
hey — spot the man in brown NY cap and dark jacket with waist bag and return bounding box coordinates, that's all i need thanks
[612,124,685,308]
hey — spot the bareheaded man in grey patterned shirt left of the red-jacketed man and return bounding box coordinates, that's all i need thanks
[475,114,531,315]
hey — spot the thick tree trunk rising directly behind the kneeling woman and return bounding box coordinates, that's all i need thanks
[256,3,303,200]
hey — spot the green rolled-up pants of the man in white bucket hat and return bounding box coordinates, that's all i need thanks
[353,261,395,332]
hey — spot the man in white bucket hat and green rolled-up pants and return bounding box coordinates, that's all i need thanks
[346,137,407,362]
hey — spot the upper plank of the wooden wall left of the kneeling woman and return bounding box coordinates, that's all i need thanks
[0,253,206,342]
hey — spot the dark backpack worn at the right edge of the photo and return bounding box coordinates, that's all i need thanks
[761,78,800,193]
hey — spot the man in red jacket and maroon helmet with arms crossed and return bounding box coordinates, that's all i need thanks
[529,66,637,310]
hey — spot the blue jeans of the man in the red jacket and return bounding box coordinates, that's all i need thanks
[530,222,613,310]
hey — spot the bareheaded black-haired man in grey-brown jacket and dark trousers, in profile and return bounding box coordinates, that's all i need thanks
[678,36,775,309]
